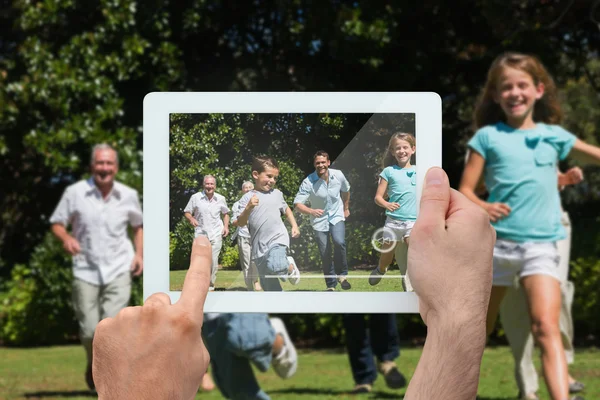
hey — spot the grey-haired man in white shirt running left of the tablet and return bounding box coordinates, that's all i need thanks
[50,144,143,390]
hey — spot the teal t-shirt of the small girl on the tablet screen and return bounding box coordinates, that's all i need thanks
[379,165,417,221]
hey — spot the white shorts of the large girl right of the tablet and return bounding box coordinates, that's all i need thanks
[493,239,560,286]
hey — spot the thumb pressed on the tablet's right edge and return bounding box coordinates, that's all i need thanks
[413,167,450,232]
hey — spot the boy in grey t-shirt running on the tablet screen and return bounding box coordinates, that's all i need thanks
[237,156,300,291]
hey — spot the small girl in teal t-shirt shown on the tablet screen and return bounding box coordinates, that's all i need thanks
[369,133,417,291]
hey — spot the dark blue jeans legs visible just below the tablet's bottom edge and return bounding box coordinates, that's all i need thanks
[343,314,400,385]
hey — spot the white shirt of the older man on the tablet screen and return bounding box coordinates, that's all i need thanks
[183,191,229,240]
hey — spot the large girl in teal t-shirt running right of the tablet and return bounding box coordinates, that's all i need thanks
[459,53,600,400]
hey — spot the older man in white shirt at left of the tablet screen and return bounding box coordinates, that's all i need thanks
[183,175,229,291]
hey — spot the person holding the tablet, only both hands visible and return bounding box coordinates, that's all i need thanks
[94,168,495,400]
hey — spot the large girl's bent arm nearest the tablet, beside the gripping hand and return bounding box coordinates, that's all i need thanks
[458,151,511,222]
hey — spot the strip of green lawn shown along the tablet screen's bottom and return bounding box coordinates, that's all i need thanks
[170,269,402,292]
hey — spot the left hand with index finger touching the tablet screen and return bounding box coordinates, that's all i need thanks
[93,236,212,400]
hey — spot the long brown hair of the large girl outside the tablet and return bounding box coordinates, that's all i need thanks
[473,52,563,130]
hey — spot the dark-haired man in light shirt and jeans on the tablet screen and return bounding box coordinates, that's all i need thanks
[294,151,352,291]
